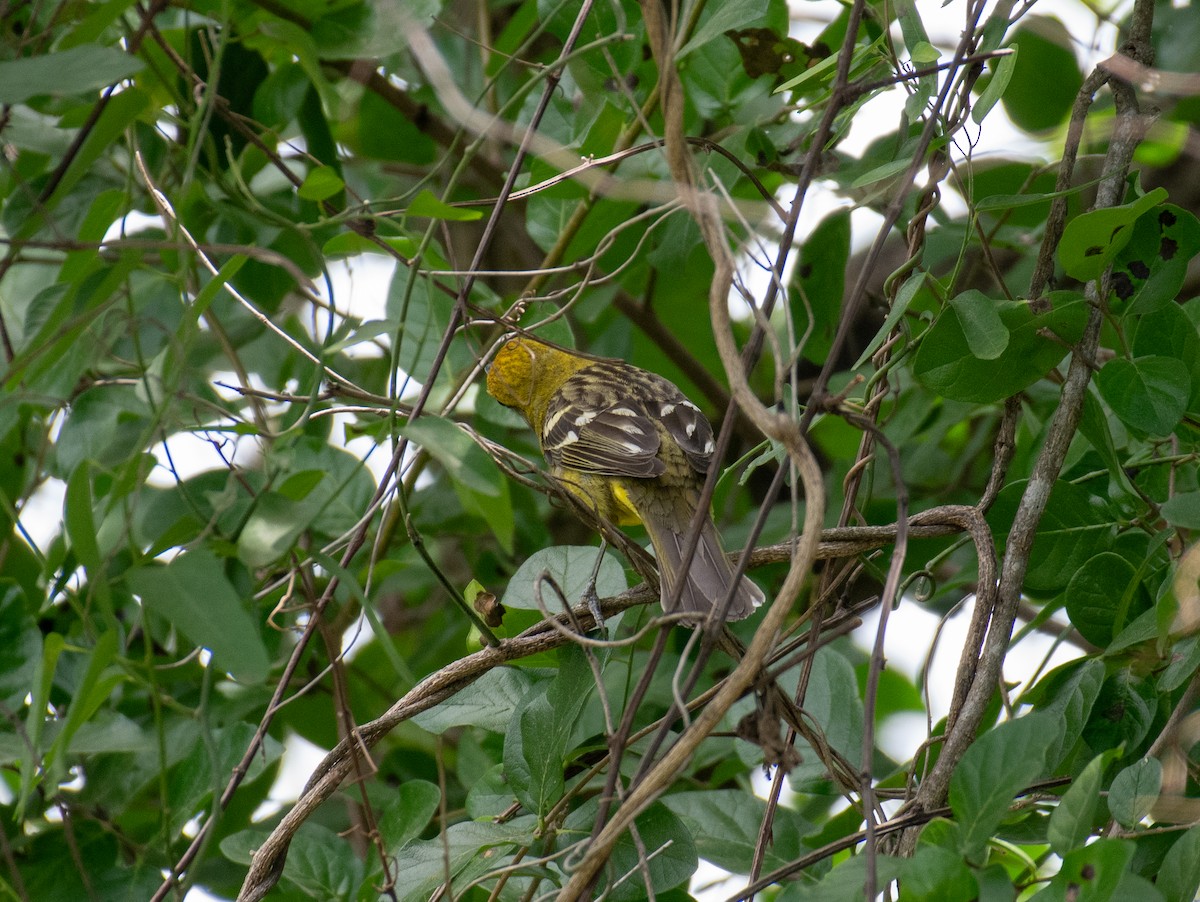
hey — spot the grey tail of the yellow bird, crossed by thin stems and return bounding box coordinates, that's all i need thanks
[643,517,763,623]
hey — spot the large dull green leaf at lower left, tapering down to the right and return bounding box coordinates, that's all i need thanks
[127,548,270,682]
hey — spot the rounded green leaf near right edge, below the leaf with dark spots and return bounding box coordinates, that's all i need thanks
[1096,356,1192,435]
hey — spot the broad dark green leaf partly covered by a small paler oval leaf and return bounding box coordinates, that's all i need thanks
[913,291,1087,404]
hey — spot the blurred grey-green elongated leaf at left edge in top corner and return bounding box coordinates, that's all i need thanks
[0,44,144,103]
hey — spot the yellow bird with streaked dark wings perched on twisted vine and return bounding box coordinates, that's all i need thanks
[487,335,763,625]
